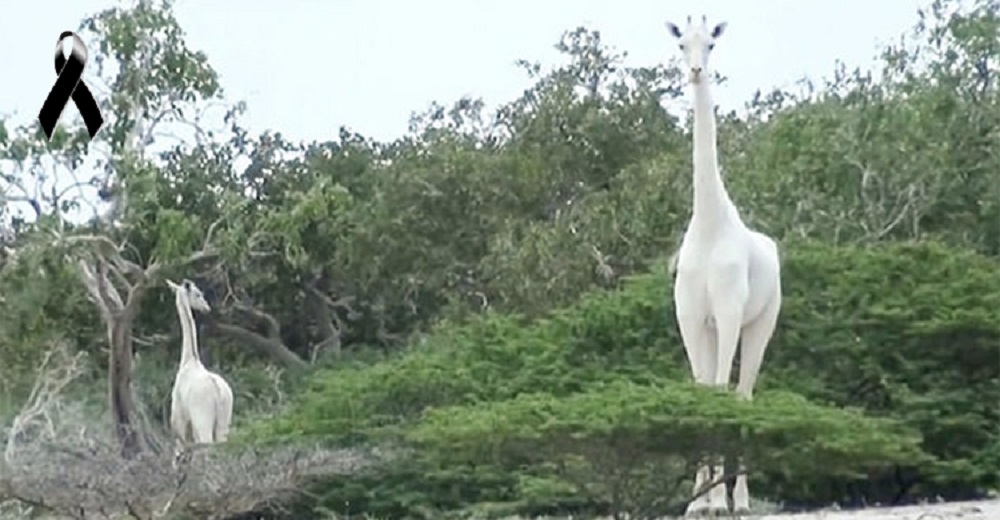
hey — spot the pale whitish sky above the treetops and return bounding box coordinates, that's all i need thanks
[0,0,928,221]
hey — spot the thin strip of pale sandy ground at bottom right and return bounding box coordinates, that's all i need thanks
[746,499,1000,520]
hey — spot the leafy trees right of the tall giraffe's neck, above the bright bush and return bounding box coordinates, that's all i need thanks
[723,1,1000,255]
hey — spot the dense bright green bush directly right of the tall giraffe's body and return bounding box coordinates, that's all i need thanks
[761,242,1000,500]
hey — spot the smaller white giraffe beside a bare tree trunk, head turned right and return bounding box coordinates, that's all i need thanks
[167,280,233,450]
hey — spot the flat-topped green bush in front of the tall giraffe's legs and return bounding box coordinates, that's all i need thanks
[407,380,927,515]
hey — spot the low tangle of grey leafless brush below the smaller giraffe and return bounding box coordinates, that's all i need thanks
[0,422,377,520]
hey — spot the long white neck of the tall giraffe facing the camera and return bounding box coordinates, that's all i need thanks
[692,78,732,225]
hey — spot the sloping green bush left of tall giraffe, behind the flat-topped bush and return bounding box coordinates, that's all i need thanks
[252,262,686,439]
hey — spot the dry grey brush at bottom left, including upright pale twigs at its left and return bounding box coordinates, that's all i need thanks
[0,345,378,520]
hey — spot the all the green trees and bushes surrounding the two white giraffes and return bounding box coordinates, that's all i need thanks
[0,0,1000,518]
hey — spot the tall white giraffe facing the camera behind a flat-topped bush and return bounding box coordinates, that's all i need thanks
[666,16,781,516]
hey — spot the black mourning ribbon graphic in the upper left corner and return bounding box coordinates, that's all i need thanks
[38,31,104,141]
